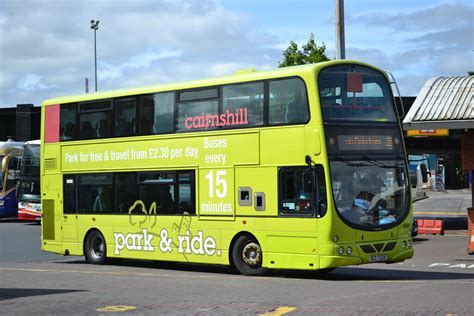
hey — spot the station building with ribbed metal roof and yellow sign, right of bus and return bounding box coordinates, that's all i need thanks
[403,76,474,189]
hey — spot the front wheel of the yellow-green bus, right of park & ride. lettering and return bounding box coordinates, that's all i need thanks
[232,235,266,275]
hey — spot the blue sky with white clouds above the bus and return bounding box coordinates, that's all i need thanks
[0,0,474,107]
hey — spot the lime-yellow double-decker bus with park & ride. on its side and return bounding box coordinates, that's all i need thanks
[41,60,413,275]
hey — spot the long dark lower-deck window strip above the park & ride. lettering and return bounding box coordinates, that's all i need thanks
[63,170,196,215]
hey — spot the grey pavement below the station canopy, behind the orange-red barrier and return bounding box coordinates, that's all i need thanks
[412,189,472,229]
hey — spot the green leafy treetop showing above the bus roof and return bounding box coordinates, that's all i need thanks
[278,33,330,68]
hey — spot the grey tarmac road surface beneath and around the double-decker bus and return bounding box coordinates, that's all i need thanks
[0,222,474,315]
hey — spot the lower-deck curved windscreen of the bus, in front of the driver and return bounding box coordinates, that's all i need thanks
[330,159,409,230]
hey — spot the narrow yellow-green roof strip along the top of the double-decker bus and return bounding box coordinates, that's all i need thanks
[43,60,382,106]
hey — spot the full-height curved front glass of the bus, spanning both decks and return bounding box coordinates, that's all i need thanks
[318,64,410,230]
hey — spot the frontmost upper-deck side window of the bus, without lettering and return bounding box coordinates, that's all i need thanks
[268,78,309,125]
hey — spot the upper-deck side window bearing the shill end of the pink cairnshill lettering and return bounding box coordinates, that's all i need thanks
[223,82,264,128]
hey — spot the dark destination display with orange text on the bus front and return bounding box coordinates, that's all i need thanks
[337,135,394,150]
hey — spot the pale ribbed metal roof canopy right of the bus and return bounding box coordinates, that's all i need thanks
[403,76,474,130]
